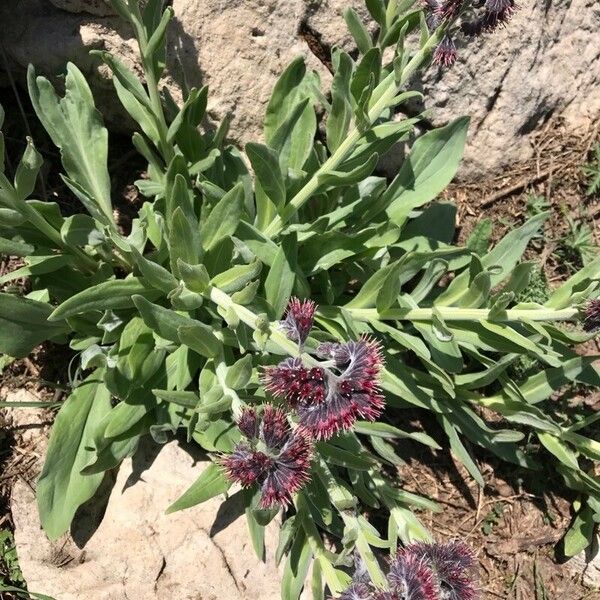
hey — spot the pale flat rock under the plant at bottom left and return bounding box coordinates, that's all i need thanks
[11,442,280,600]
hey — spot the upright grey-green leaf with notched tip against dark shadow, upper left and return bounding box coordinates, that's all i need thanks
[27,63,113,224]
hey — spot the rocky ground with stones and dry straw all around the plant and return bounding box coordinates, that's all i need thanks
[0,0,600,600]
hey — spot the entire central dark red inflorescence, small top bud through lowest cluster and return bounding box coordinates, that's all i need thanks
[221,298,385,508]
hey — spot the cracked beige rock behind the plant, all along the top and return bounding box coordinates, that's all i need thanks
[0,0,600,178]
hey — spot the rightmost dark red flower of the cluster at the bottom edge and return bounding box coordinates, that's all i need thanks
[399,540,479,600]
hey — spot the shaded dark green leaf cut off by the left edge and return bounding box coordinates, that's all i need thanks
[0,292,70,358]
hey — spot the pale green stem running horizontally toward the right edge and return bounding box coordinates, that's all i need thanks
[345,306,579,322]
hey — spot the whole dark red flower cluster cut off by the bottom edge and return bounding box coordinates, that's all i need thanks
[339,541,479,600]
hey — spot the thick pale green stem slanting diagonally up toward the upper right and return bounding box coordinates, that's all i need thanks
[264,28,445,238]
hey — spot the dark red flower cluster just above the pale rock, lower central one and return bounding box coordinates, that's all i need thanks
[221,405,312,508]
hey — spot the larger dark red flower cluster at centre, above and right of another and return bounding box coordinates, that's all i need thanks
[263,337,384,440]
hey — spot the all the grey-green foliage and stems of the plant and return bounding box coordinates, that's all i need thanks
[0,0,600,600]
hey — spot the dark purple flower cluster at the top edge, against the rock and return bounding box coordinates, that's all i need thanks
[423,0,517,67]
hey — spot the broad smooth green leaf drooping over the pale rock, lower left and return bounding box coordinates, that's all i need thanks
[37,372,111,539]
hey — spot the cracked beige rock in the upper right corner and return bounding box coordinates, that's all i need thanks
[424,0,600,178]
